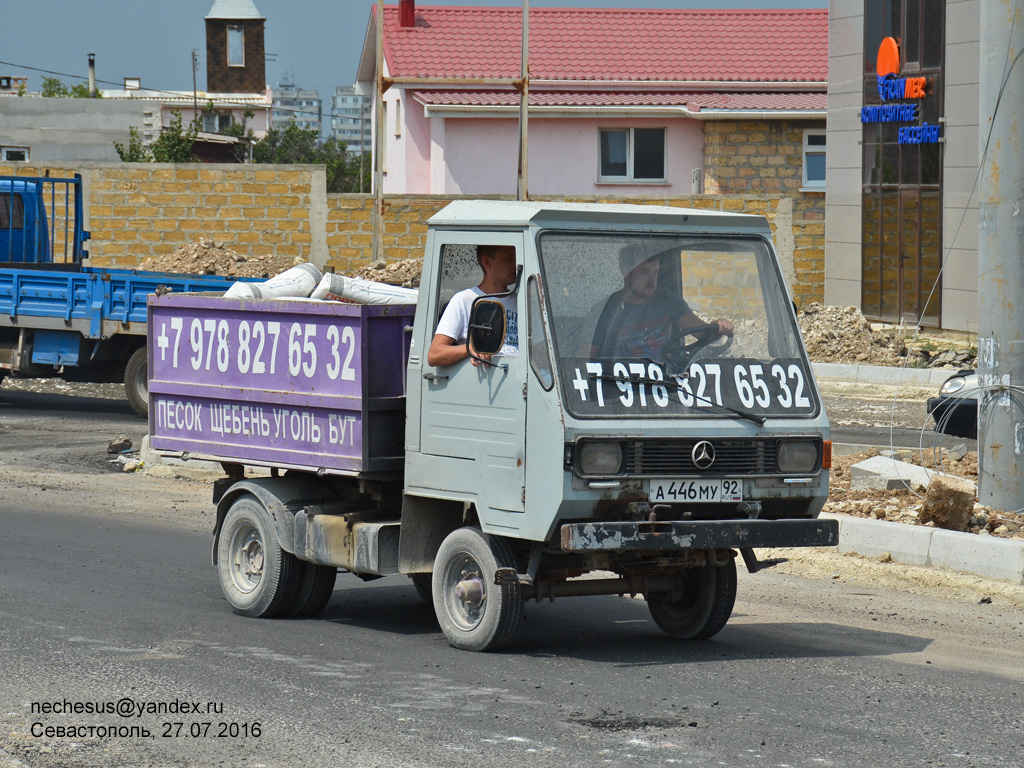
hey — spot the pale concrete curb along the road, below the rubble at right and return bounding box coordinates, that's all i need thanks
[820,512,1024,586]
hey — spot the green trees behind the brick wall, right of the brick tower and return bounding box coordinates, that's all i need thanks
[252,120,370,193]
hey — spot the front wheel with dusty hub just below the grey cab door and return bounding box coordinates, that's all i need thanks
[431,527,522,650]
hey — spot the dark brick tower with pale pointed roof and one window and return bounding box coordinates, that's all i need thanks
[206,0,266,93]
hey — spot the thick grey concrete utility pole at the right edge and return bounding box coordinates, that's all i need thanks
[978,2,1024,511]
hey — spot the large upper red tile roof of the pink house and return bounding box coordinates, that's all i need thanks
[374,5,828,87]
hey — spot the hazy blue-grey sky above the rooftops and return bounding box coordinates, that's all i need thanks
[0,0,828,120]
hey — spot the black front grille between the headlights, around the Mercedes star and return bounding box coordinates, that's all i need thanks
[626,439,776,477]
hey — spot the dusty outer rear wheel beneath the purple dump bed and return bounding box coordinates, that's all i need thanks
[217,494,301,618]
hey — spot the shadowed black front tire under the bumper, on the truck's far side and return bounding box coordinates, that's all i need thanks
[645,557,736,640]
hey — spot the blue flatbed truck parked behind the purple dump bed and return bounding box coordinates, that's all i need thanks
[0,174,251,417]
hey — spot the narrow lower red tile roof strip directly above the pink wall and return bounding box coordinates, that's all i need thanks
[416,90,826,113]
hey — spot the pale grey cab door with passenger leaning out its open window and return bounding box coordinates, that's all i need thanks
[407,232,528,534]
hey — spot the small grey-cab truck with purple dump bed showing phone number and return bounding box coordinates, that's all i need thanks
[148,201,838,650]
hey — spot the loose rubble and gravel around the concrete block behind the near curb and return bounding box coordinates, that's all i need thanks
[824,449,1024,540]
